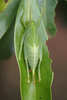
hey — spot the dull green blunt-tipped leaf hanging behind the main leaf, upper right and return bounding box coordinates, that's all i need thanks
[37,0,57,38]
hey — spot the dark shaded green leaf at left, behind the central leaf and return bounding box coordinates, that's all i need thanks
[0,19,15,61]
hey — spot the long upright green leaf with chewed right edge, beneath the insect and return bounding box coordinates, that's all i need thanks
[14,0,53,100]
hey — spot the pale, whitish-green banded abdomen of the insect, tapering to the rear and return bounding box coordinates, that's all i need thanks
[25,42,40,69]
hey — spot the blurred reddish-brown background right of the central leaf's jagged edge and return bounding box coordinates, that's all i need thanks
[47,0,67,100]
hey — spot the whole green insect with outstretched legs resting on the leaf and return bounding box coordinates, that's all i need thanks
[19,5,43,84]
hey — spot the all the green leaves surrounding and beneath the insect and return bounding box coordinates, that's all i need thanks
[0,0,57,100]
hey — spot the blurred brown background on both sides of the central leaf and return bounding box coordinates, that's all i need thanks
[0,0,67,100]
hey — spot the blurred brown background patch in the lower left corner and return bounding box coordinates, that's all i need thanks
[0,56,21,100]
